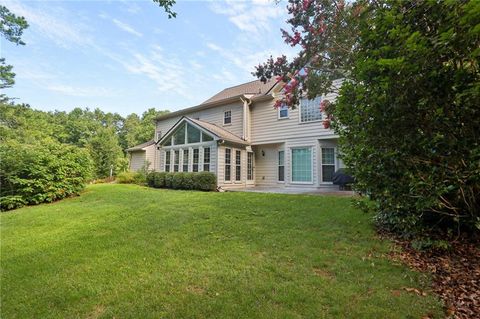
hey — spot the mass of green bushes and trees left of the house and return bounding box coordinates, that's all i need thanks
[0,103,169,209]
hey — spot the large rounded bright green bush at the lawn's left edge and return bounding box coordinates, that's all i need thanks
[0,139,92,210]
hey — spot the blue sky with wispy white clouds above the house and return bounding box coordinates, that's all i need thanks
[0,0,295,115]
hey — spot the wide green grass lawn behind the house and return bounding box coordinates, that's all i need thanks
[1,184,441,319]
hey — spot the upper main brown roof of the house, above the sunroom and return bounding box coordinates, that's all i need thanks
[157,80,277,120]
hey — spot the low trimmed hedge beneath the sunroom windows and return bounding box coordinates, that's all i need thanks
[147,172,217,191]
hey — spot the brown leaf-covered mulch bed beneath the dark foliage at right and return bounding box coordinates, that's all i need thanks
[382,234,480,319]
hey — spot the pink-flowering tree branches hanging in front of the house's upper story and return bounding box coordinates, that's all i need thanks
[253,0,361,128]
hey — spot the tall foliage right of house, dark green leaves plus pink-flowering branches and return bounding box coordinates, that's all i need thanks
[256,0,480,235]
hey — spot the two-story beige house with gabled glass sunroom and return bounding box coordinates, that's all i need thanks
[127,80,343,189]
